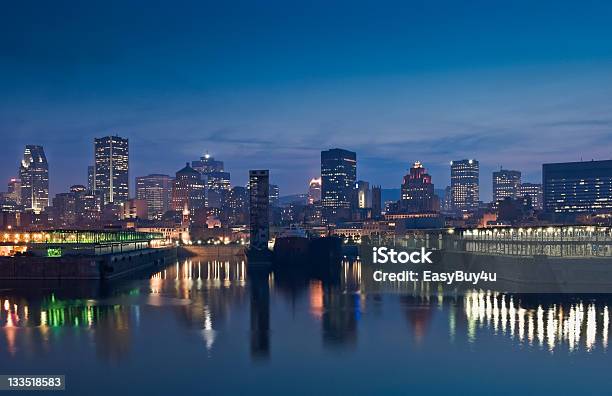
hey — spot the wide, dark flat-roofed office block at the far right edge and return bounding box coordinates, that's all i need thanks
[542,160,612,214]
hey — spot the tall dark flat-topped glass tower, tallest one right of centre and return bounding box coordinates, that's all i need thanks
[321,148,357,218]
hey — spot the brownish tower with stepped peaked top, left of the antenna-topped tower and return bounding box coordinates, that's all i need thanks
[172,162,205,212]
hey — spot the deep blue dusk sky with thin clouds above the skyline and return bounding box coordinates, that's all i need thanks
[0,0,612,200]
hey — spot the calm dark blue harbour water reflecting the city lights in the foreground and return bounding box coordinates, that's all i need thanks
[0,259,612,395]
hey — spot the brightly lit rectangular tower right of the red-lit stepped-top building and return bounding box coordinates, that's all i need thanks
[451,159,480,213]
